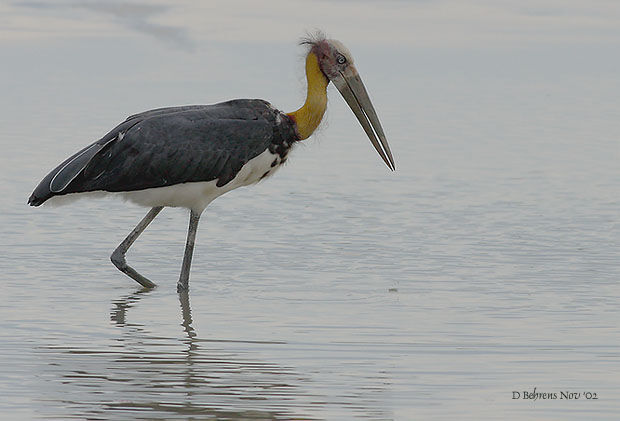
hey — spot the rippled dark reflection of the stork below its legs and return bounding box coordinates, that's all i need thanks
[38,290,309,419]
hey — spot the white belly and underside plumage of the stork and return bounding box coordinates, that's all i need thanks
[46,150,281,213]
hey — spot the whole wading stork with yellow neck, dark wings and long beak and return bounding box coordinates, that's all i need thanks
[28,34,395,291]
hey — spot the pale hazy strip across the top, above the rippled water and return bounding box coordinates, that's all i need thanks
[0,0,620,48]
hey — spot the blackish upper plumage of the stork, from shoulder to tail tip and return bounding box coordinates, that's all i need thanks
[28,99,298,206]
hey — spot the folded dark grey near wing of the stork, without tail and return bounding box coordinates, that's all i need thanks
[75,113,273,192]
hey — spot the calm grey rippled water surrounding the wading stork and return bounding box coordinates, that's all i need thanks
[0,2,620,420]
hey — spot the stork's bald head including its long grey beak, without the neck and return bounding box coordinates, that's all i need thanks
[302,34,395,170]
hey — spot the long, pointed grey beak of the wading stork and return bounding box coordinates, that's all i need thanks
[331,65,396,171]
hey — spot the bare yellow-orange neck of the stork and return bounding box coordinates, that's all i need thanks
[288,53,329,139]
